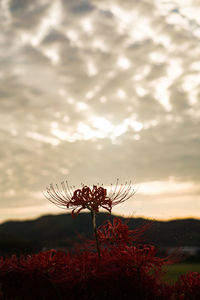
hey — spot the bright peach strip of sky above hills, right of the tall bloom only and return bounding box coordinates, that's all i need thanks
[113,180,200,220]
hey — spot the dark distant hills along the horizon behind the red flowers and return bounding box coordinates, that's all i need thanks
[0,213,200,255]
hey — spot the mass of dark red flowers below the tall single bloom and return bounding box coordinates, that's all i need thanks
[0,218,200,300]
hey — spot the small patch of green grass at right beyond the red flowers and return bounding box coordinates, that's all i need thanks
[164,263,200,284]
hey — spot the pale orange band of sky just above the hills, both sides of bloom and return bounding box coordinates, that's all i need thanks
[0,179,200,223]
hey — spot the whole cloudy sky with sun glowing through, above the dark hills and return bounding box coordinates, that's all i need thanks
[0,0,200,222]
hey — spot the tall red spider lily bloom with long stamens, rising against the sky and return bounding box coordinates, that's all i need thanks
[45,180,135,216]
